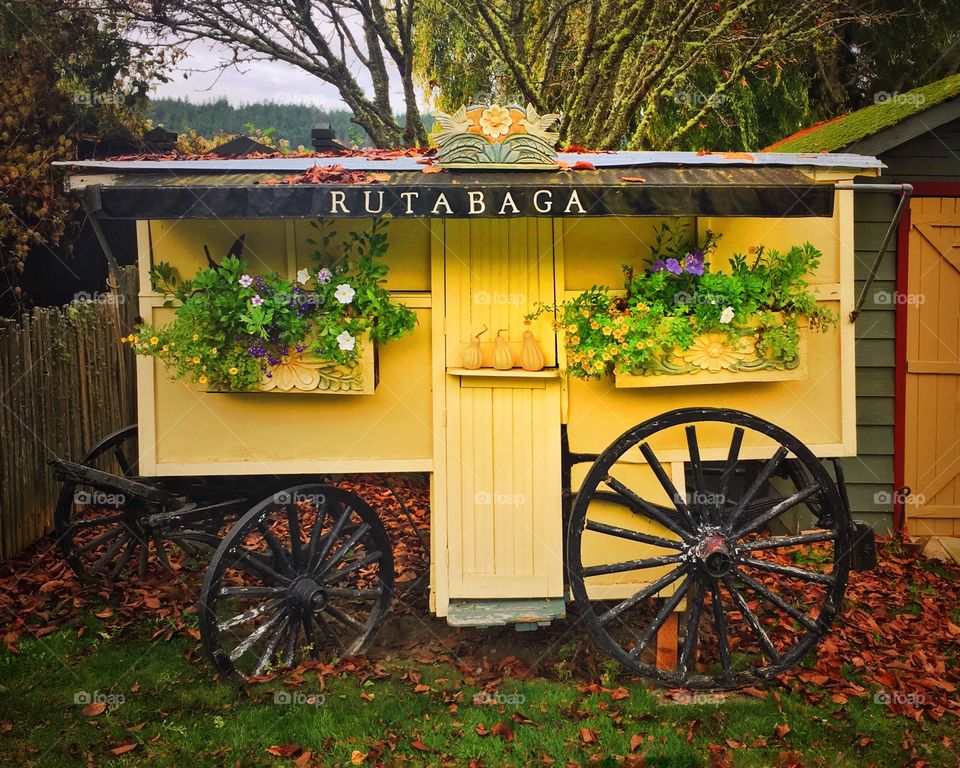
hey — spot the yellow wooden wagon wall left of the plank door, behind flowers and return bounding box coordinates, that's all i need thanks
[138,220,433,475]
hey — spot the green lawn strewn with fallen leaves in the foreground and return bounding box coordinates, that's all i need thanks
[0,611,957,768]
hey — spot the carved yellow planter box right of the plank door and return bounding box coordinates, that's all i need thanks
[614,318,809,389]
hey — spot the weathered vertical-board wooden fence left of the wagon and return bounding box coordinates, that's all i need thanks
[0,267,137,562]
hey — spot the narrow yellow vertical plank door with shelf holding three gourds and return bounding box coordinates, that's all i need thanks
[444,219,563,599]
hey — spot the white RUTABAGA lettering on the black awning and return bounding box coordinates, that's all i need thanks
[314,186,592,218]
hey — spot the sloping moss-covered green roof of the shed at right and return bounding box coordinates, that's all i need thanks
[764,74,960,156]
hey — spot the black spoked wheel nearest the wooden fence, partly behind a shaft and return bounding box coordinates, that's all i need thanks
[54,425,220,582]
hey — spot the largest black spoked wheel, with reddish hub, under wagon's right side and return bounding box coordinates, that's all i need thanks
[568,408,851,689]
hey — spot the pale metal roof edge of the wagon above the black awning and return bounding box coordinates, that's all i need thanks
[54,152,884,173]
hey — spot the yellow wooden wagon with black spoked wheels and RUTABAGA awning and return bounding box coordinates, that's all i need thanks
[53,107,881,688]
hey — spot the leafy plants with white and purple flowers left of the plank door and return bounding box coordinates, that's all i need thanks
[128,219,416,391]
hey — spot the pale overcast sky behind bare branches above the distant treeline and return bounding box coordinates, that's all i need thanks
[154,41,403,109]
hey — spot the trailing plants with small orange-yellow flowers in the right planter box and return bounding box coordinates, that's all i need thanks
[528,224,837,378]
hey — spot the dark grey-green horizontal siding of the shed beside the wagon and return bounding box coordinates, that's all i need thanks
[843,115,960,533]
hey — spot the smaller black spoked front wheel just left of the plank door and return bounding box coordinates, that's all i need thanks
[200,485,394,679]
